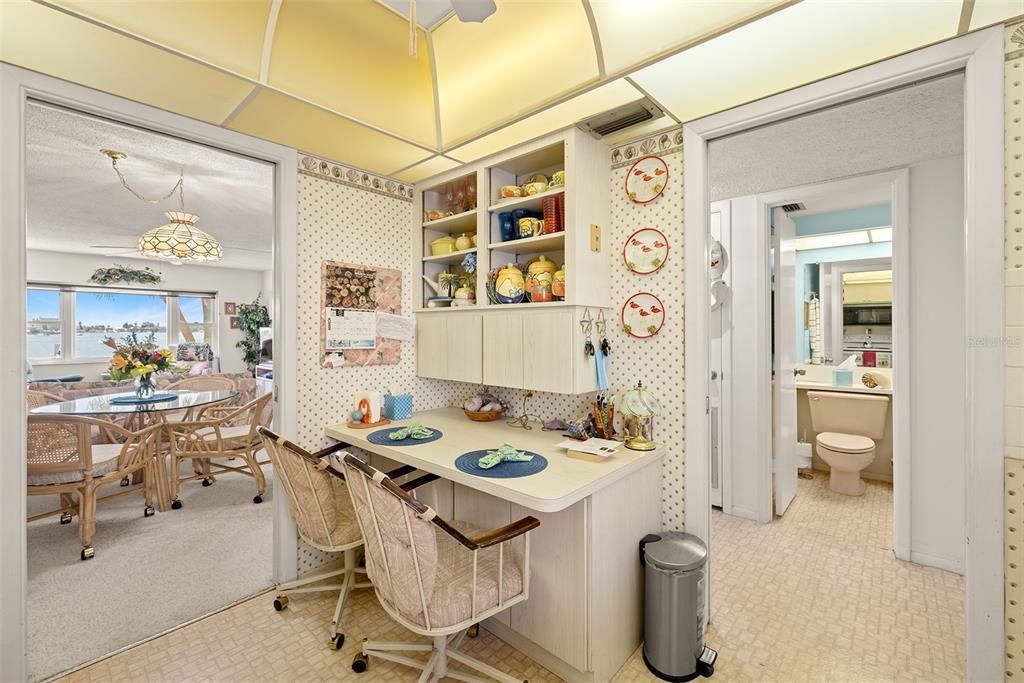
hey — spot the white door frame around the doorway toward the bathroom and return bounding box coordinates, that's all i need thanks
[683,27,1005,681]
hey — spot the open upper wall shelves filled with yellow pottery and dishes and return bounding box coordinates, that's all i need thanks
[414,128,611,312]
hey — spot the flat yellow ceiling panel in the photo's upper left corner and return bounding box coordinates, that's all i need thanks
[0,0,252,124]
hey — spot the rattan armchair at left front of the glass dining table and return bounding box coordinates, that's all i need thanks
[27,415,160,560]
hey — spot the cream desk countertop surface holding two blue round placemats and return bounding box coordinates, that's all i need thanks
[327,408,662,512]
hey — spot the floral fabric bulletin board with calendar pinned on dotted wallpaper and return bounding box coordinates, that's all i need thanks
[321,261,401,368]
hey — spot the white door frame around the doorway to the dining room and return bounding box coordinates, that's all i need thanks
[0,65,298,681]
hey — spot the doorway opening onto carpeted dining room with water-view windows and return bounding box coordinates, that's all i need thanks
[20,99,280,680]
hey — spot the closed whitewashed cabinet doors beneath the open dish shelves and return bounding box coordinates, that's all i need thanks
[416,305,610,394]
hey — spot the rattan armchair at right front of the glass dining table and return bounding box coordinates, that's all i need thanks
[165,393,273,510]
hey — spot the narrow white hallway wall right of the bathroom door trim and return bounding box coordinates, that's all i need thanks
[909,156,967,571]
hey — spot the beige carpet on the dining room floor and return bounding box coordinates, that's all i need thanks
[28,465,273,681]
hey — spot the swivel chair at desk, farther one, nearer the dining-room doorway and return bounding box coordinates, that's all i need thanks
[258,427,373,649]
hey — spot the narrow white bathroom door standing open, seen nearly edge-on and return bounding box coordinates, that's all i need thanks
[772,209,797,515]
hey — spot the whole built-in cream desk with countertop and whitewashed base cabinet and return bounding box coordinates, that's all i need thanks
[326,408,663,683]
